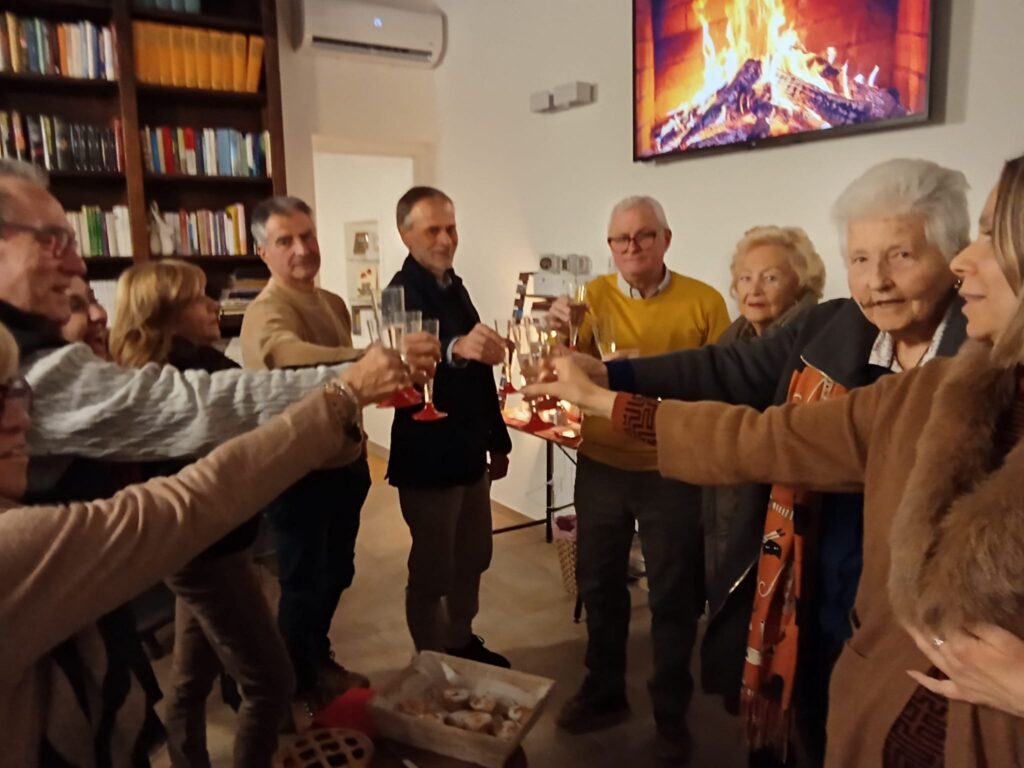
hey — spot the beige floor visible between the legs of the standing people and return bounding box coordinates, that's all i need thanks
[149,463,745,768]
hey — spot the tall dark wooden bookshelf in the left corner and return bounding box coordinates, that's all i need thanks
[0,0,285,290]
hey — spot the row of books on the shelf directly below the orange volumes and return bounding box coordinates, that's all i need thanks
[141,126,272,177]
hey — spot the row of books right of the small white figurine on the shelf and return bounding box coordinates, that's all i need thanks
[151,203,250,256]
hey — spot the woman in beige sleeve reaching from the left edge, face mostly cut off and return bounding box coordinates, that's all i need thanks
[0,315,409,768]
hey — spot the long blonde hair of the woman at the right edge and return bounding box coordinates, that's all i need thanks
[992,155,1024,367]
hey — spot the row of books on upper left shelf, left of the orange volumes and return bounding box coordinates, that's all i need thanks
[0,11,118,80]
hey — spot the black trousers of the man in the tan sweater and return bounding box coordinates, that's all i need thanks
[267,458,370,692]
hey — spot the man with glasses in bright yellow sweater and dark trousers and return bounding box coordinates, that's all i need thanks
[551,197,729,764]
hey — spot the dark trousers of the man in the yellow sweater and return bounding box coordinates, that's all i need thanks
[575,456,703,729]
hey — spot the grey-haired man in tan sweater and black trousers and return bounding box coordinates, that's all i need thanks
[242,198,370,709]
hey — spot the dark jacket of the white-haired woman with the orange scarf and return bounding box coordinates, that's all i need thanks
[607,297,967,709]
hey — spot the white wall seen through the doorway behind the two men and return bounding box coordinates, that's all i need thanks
[313,152,413,447]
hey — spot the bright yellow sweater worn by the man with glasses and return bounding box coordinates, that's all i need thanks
[579,272,729,472]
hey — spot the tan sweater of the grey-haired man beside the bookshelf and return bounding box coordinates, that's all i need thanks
[242,278,360,369]
